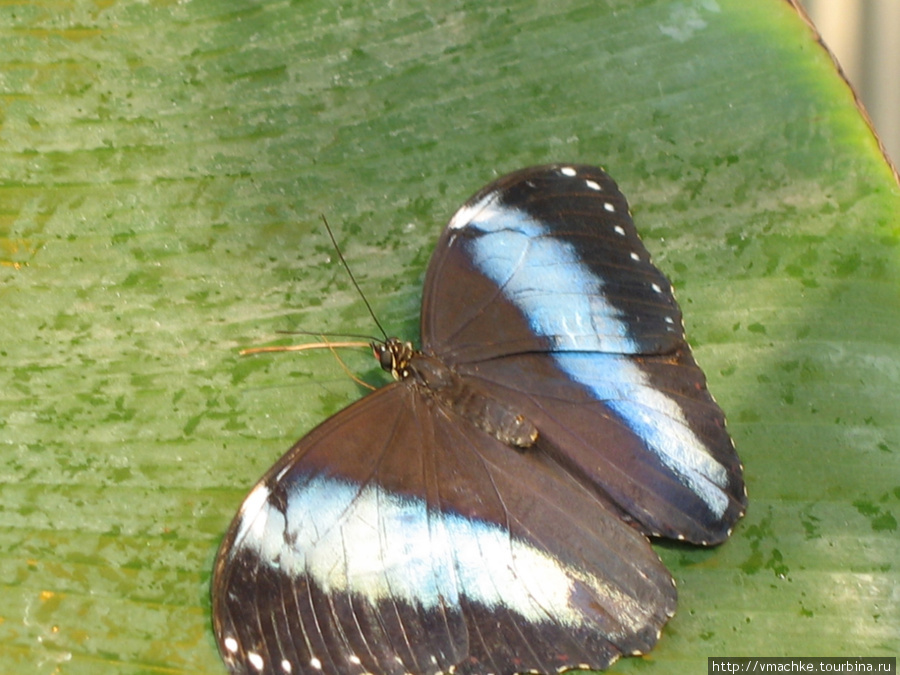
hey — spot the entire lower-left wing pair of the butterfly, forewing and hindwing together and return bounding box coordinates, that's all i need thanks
[213,372,675,675]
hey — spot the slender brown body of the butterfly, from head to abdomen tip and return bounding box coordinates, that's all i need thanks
[372,338,538,448]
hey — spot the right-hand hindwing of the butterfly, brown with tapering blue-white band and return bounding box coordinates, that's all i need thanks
[459,352,745,545]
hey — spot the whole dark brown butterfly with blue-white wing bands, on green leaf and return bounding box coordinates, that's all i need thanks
[212,164,747,675]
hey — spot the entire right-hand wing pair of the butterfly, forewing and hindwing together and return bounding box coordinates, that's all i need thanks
[422,165,746,544]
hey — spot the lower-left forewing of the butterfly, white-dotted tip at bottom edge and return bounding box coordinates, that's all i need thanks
[213,384,468,675]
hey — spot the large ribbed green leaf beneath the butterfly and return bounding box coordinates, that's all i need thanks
[0,0,900,675]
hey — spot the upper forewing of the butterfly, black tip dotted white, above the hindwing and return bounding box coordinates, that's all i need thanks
[422,166,683,364]
